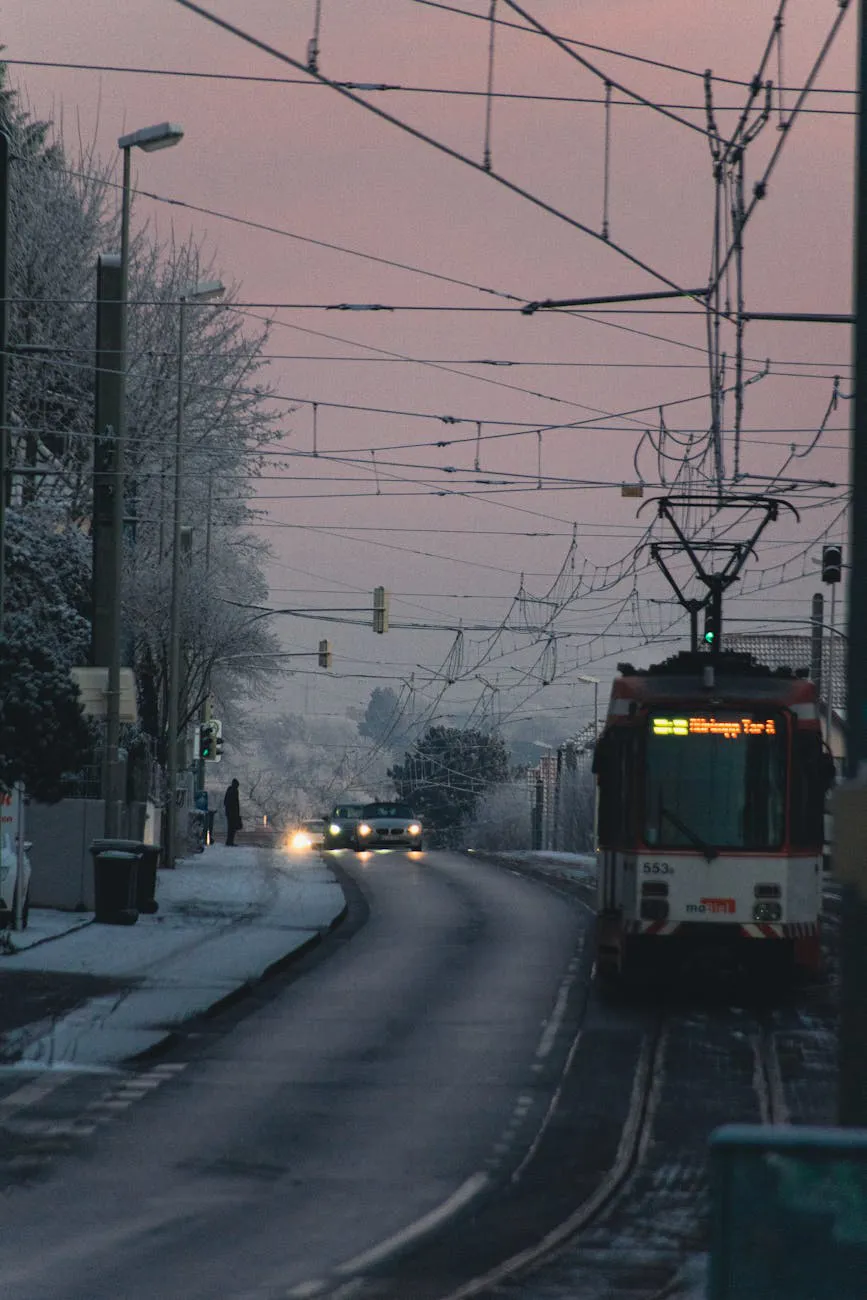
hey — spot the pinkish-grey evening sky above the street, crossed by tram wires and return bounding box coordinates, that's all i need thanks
[0,0,855,743]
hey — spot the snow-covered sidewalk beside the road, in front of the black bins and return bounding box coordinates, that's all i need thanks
[0,845,346,1070]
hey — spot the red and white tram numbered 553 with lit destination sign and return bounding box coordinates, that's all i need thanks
[594,651,833,979]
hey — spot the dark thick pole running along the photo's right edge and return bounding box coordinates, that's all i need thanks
[838,0,867,1127]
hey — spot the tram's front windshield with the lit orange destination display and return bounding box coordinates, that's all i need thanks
[643,711,786,852]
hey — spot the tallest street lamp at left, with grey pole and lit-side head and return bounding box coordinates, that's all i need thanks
[105,122,183,837]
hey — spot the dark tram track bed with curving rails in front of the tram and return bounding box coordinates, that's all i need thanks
[288,861,833,1300]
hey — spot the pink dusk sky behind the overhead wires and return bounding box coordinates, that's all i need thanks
[1,0,855,724]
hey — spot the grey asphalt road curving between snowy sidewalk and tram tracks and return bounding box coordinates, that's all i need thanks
[1,853,588,1300]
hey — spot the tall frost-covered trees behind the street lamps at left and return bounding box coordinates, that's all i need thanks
[0,64,286,780]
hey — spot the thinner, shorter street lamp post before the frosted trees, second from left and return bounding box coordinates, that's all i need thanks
[165,280,225,867]
